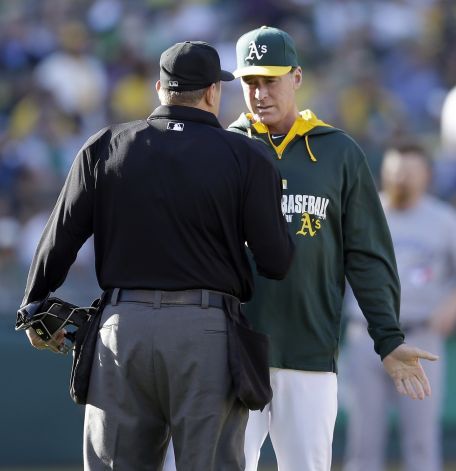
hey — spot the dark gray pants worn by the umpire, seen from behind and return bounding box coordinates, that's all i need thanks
[84,302,248,471]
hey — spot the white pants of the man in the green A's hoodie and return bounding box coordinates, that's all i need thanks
[244,368,337,471]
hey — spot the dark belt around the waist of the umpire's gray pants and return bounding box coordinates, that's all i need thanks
[106,288,229,309]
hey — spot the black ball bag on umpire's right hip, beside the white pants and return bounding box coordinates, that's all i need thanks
[223,296,272,410]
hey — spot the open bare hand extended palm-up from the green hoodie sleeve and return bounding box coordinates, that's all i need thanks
[383,343,439,399]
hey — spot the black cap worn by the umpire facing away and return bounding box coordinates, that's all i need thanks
[160,41,234,91]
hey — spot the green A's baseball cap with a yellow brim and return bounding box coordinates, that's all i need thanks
[233,26,299,77]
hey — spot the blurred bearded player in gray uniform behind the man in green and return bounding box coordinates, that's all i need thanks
[344,141,456,471]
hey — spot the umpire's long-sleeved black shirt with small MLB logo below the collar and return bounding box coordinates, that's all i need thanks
[23,106,293,305]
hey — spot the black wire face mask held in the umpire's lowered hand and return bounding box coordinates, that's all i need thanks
[16,297,96,353]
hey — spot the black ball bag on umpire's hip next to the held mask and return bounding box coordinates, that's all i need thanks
[70,293,104,405]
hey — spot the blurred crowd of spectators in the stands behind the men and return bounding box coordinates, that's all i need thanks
[0,0,456,315]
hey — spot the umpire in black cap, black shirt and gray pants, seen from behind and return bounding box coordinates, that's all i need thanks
[22,41,293,471]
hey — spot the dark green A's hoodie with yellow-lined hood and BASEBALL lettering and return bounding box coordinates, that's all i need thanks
[229,110,404,371]
